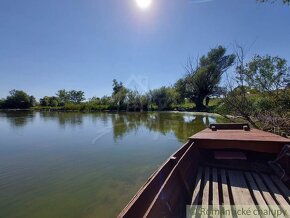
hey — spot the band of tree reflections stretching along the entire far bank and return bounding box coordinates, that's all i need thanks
[0,111,222,142]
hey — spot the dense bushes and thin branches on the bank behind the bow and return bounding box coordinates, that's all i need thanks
[218,55,290,135]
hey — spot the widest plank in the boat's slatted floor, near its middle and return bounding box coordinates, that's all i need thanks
[228,170,255,205]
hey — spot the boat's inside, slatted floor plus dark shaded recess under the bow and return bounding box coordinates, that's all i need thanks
[190,150,290,215]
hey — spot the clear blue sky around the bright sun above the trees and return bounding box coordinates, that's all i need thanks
[0,0,290,98]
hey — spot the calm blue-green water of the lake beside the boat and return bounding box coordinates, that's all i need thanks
[0,112,222,218]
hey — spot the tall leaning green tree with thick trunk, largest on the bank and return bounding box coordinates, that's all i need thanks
[175,46,235,111]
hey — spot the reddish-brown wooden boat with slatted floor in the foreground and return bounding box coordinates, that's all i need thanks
[118,124,290,218]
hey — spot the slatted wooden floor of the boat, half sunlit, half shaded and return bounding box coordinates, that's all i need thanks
[191,166,290,212]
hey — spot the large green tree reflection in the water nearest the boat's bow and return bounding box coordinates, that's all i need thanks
[112,112,223,142]
